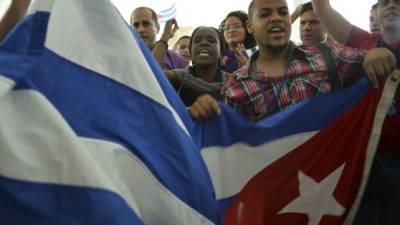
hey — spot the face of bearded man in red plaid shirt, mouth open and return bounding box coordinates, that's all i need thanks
[248,0,292,50]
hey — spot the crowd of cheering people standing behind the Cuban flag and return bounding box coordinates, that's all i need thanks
[0,0,400,225]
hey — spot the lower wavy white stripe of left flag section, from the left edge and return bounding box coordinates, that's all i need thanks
[0,90,216,225]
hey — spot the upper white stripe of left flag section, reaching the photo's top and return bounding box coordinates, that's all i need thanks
[38,0,189,134]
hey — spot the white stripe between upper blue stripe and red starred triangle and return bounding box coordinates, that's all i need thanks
[201,132,317,199]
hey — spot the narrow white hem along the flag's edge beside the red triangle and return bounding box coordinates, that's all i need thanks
[343,70,400,225]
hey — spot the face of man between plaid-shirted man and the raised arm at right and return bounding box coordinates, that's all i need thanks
[300,11,326,44]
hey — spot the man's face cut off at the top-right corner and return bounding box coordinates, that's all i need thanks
[378,0,400,34]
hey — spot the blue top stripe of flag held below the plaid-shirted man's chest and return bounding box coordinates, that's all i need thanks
[193,78,370,148]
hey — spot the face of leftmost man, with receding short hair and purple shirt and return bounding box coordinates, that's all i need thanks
[131,9,160,47]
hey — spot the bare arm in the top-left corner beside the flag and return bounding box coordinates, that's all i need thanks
[0,0,31,42]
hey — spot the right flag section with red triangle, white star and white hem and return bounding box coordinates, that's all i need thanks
[194,76,397,225]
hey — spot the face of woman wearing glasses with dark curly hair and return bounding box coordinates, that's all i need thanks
[224,16,246,47]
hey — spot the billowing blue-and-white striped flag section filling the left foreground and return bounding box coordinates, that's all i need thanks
[0,0,219,225]
